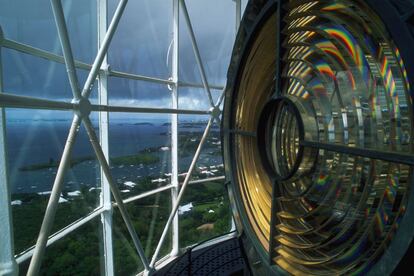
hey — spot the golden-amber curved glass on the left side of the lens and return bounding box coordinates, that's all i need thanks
[234,12,276,249]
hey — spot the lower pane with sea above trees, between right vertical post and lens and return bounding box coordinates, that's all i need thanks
[178,115,231,247]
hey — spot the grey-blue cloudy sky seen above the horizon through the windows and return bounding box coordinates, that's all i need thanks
[0,0,243,119]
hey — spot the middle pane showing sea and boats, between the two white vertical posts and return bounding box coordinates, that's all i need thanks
[109,113,171,198]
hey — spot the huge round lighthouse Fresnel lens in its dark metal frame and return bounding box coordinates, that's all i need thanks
[223,0,414,275]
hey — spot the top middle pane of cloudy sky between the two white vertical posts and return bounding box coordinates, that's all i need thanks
[108,0,172,79]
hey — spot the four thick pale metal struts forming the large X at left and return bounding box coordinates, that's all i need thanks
[28,0,155,275]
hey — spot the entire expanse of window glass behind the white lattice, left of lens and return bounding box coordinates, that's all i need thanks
[0,0,236,275]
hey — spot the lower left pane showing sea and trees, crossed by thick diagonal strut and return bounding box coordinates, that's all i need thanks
[7,109,100,253]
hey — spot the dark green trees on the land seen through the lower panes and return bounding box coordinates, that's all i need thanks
[12,177,230,275]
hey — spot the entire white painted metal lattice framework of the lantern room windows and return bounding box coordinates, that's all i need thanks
[0,0,241,275]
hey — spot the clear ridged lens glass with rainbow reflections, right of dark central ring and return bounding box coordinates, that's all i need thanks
[276,1,413,274]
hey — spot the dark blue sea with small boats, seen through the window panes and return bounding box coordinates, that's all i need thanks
[7,118,222,194]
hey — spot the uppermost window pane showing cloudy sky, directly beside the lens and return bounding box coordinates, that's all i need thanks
[179,0,236,85]
